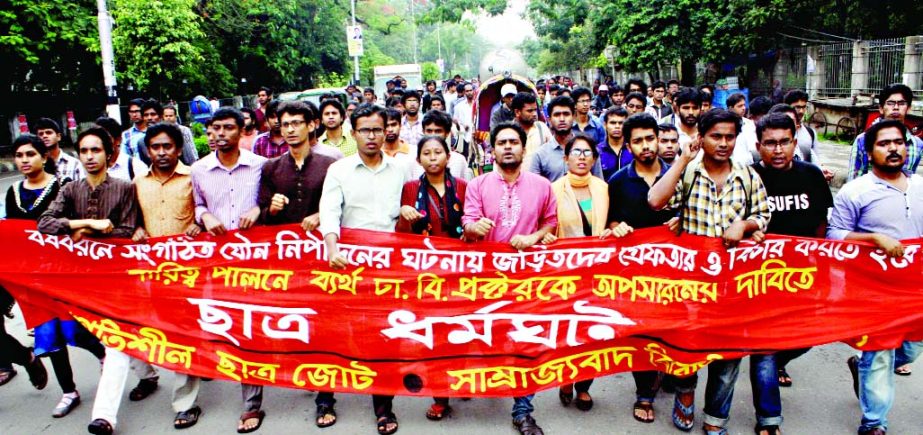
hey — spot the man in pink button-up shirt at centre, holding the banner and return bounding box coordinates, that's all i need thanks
[462,122,558,435]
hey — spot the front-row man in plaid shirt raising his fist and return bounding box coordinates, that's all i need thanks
[648,109,770,435]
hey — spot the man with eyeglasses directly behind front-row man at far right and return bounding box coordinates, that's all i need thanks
[848,83,923,181]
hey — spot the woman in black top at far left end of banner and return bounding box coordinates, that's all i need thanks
[3,135,106,417]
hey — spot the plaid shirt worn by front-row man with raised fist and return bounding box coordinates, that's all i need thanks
[669,160,770,237]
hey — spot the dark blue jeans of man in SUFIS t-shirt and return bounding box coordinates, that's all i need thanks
[750,348,811,426]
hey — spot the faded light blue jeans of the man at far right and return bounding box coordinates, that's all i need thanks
[859,341,923,432]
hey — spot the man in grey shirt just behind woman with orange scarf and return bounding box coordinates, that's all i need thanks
[528,95,603,183]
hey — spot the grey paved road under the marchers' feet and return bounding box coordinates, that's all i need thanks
[0,144,923,435]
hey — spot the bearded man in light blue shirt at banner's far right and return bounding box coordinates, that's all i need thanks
[827,120,923,435]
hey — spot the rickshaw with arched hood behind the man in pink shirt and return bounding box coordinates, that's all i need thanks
[468,73,545,173]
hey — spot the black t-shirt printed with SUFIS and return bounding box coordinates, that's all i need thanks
[753,160,833,237]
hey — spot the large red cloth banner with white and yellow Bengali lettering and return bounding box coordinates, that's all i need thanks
[0,221,923,396]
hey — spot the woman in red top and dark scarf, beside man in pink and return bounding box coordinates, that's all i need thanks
[397,136,467,420]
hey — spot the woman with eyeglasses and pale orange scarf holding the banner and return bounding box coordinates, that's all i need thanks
[545,134,611,411]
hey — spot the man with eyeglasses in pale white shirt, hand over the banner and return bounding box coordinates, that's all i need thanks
[316,104,410,434]
